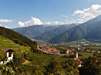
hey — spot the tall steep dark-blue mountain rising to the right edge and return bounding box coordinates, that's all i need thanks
[49,16,101,43]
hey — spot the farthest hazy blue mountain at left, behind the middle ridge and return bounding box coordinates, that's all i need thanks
[12,25,57,39]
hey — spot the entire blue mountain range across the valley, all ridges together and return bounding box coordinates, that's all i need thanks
[13,16,101,43]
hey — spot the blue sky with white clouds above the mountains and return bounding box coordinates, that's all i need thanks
[0,0,101,28]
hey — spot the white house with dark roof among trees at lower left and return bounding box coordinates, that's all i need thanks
[0,49,14,65]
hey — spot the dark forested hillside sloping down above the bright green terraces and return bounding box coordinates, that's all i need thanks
[0,27,37,49]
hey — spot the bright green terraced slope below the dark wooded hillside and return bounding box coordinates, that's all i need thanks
[0,36,29,52]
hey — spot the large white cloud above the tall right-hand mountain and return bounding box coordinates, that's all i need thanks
[73,4,101,23]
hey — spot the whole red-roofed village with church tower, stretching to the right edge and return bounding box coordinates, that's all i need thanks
[37,44,101,67]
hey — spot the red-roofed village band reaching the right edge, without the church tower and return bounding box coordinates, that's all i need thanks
[36,44,101,57]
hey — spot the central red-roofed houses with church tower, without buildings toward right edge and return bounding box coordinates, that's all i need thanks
[38,44,82,67]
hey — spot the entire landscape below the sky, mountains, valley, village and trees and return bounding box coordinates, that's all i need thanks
[0,16,101,75]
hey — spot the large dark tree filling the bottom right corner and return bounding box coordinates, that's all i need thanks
[80,57,101,75]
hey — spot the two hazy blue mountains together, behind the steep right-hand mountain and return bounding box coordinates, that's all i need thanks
[12,24,78,41]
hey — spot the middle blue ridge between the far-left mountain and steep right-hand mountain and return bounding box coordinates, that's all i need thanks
[35,24,76,41]
